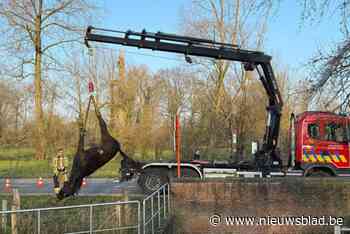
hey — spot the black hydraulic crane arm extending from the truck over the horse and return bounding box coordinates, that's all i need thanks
[85,26,283,170]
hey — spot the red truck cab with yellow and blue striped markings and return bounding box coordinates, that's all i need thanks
[291,111,350,176]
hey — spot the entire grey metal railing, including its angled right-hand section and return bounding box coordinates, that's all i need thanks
[0,184,170,234]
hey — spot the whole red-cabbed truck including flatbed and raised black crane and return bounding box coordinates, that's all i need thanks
[85,26,350,192]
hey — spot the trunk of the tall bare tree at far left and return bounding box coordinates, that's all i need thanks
[34,1,45,160]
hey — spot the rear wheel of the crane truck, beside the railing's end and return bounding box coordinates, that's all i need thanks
[137,170,169,194]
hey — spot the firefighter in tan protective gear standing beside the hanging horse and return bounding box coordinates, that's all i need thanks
[53,148,68,194]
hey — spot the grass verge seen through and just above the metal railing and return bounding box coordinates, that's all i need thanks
[0,195,140,234]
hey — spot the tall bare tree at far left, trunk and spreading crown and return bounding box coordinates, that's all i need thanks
[0,0,92,159]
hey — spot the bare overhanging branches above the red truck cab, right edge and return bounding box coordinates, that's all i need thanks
[299,0,350,111]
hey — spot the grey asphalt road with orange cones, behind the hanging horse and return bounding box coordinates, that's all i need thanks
[0,178,142,195]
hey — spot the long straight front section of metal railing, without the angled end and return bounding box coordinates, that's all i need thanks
[0,201,141,234]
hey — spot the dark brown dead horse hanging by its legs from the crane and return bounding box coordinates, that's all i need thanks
[57,108,128,200]
